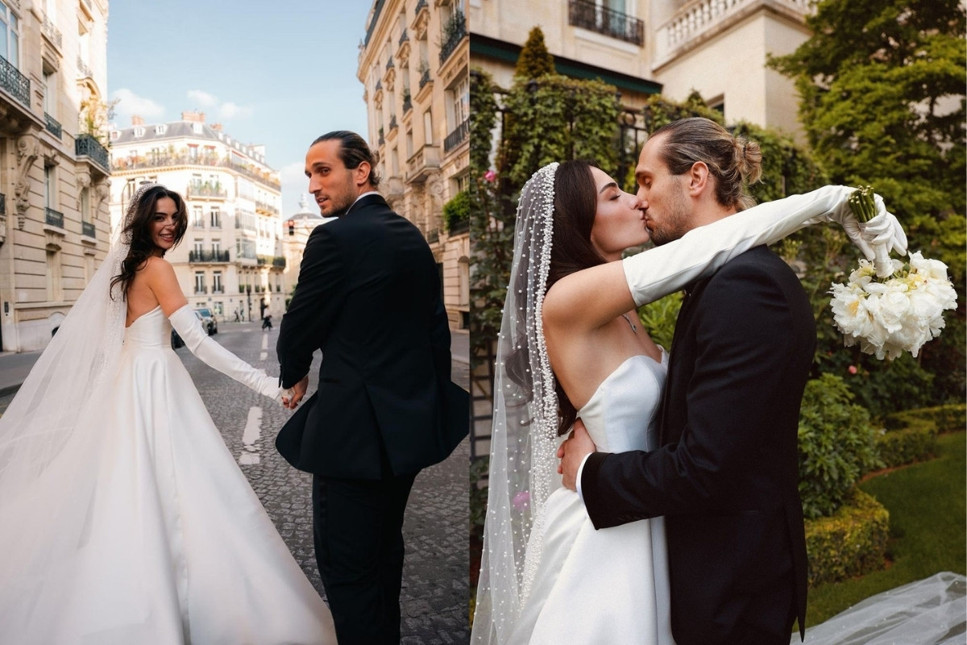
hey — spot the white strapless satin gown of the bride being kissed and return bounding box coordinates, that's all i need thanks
[509,354,674,645]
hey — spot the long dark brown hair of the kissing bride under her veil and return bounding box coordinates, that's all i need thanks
[506,160,606,436]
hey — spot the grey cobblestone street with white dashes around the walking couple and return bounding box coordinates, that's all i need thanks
[0,323,470,645]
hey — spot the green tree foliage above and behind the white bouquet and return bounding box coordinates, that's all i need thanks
[771,0,967,409]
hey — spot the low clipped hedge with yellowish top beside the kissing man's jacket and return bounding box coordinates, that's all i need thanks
[806,488,890,587]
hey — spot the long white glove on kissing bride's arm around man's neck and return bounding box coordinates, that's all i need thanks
[623,186,907,306]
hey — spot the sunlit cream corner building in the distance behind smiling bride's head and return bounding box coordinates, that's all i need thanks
[110,112,288,322]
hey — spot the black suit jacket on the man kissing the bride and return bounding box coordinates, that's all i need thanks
[581,247,816,645]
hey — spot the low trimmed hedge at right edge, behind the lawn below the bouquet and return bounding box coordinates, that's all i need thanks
[876,404,967,468]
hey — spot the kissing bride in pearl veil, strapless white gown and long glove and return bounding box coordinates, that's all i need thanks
[471,157,895,645]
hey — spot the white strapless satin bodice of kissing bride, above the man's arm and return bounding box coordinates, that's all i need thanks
[578,354,666,452]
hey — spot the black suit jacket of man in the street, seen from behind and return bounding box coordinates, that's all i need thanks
[276,195,469,479]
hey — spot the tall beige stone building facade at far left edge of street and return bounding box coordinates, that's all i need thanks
[0,0,110,352]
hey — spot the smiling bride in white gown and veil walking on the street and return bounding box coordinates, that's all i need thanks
[0,185,336,645]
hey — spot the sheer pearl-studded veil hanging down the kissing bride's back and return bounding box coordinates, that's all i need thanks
[471,163,560,643]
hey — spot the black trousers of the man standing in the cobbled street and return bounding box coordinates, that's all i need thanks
[312,475,416,645]
